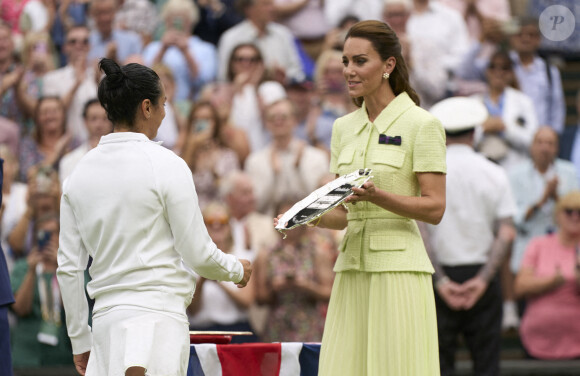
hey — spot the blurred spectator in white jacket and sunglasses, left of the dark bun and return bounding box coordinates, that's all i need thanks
[41,26,99,142]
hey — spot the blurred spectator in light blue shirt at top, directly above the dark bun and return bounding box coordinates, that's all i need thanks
[89,0,143,62]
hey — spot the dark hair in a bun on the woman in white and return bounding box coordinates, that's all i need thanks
[98,58,161,128]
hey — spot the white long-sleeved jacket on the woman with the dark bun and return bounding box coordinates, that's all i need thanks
[57,132,243,354]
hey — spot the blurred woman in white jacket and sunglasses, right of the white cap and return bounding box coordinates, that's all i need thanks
[475,51,538,169]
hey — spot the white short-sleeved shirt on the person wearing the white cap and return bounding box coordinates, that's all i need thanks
[428,145,516,266]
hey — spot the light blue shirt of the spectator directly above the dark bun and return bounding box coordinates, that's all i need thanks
[89,30,143,63]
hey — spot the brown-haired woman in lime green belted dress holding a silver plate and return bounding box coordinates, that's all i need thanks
[315,21,446,376]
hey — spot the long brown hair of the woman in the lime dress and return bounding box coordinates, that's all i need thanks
[344,20,420,107]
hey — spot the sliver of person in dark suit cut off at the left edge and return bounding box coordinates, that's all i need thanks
[0,159,14,376]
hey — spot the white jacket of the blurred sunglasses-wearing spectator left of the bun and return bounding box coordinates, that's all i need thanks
[42,64,97,142]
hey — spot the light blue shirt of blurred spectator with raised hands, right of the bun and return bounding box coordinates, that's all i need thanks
[143,36,217,101]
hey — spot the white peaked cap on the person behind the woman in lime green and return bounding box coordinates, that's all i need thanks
[429,97,489,133]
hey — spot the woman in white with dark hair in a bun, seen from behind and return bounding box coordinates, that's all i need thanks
[57,59,251,376]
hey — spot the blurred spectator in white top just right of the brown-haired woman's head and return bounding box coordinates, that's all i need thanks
[406,0,469,108]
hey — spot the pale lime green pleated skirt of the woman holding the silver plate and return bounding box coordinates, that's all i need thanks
[318,271,440,376]
